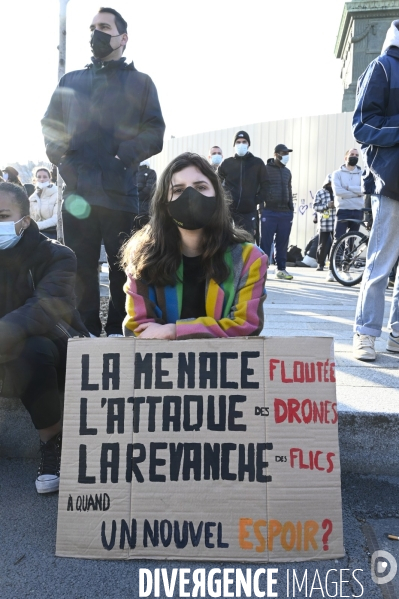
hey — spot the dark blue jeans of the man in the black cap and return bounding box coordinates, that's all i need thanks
[260,209,293,270]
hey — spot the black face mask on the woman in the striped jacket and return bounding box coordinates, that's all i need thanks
[168,187,216,231]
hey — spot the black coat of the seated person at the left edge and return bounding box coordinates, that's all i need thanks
[0,221,88,361]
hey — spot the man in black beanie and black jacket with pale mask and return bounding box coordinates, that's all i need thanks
[218,131,266,242]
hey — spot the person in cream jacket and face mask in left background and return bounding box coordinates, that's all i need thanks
[29,166,58,239]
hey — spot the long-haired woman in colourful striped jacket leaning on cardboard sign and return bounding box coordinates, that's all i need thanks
[122,152,267,339]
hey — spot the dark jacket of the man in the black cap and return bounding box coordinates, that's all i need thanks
[265,158,294,212]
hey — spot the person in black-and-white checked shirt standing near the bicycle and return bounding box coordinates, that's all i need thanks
[313,175,336,280]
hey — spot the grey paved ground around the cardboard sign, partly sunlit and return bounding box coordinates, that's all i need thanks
[0,268,399,599]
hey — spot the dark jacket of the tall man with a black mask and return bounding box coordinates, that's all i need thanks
[42,59,165,213]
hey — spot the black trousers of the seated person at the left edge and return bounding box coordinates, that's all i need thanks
[2,337,66,429]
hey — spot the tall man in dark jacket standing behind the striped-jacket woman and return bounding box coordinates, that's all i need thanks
[42,8,165,336]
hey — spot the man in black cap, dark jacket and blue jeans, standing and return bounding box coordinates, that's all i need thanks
[261,144,294,281]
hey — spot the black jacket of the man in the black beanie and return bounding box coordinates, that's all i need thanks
[218,152,266,214]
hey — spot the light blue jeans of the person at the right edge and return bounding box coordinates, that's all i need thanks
[354,196,399,337]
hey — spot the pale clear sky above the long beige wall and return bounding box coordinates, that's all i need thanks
[0,0,345,167]
